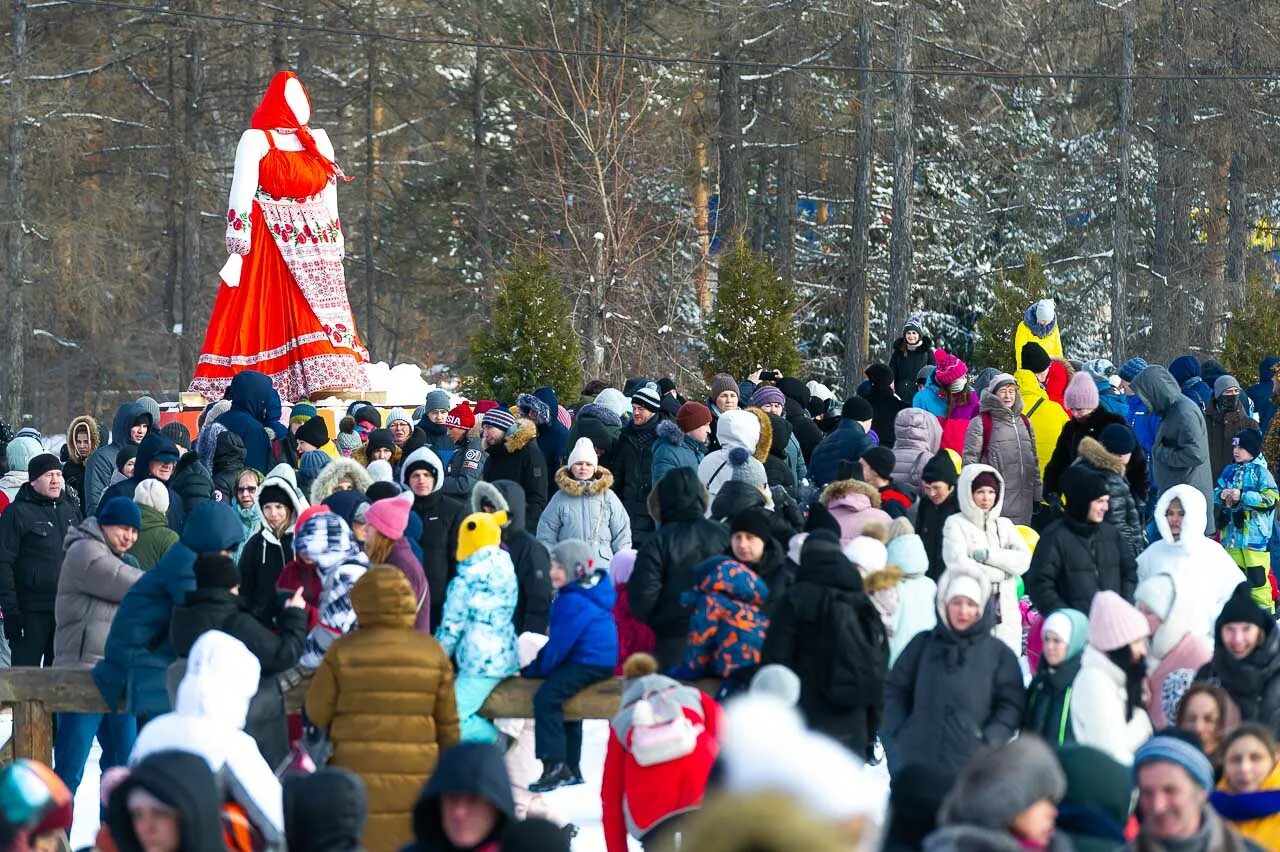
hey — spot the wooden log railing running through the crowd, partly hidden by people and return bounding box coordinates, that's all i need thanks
[0,668,719,764]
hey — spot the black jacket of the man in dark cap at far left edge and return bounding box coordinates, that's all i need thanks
[0,482,81,614]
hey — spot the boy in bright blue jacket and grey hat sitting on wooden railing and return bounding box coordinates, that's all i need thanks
[521,539,618,793]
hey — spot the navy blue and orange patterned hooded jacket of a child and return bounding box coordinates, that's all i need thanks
[671,556,769,681]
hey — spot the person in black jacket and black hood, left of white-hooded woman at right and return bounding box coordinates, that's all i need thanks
[1027,466,1138,613]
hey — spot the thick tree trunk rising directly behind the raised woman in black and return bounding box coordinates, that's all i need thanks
[884,0,915,356]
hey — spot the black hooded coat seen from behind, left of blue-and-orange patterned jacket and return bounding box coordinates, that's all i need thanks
[627,467,730,641]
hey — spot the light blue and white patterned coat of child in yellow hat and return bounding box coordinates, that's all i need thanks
[435,548,520,678]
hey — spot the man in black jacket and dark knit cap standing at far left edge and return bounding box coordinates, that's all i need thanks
[0,453,81,665]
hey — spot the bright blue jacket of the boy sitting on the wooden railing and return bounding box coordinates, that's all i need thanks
[522,571,618,678]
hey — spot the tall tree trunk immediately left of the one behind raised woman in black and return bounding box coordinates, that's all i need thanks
[845,0,876,395]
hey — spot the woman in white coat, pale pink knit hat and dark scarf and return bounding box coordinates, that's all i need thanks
[1071,591,1152,766]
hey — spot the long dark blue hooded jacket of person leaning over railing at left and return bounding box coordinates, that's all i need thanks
[93,500,244,716]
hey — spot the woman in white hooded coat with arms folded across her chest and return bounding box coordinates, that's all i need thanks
[942,464,1032,654]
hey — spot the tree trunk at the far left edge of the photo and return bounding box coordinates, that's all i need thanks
[0,0,27,422]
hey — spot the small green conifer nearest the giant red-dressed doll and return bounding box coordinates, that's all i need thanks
[471,253,582,402]
